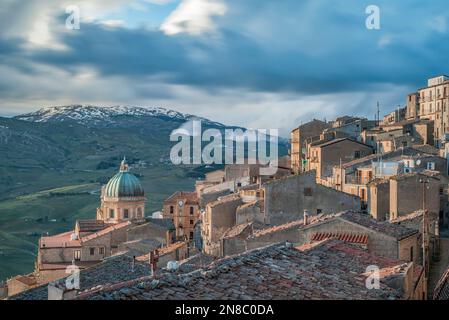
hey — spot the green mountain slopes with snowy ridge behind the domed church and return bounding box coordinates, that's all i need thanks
[0,105,287,280]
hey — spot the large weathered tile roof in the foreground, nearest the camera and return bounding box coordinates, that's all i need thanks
[79,239,404,300]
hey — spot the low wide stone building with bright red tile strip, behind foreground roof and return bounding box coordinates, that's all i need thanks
[221,211,421,264]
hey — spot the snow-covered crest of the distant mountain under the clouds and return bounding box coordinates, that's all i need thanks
[14,105,223,126]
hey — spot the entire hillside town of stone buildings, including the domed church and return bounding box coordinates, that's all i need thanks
[4,76,449,300]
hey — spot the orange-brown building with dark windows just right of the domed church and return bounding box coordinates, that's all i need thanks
[162,191,200,241]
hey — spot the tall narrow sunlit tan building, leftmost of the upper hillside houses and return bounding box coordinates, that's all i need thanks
[290,119,330,173]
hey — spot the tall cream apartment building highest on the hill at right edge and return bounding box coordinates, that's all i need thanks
[406,75,449,147]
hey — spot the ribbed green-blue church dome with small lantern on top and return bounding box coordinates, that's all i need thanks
[104,160,145,198]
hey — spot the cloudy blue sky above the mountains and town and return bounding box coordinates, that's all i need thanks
[0,0,449,136]
